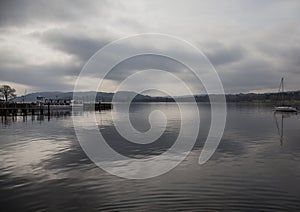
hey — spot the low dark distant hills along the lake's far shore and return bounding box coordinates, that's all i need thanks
[12,91,300,102]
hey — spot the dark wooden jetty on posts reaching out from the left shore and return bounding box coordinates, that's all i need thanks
[0,102,112,116]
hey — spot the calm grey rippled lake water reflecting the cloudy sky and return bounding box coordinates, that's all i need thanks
[0,103,300,211]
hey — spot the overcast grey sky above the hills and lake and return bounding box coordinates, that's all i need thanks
[0,0,300,95]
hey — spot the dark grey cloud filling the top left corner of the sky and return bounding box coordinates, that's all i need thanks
[0,0,107,26]
